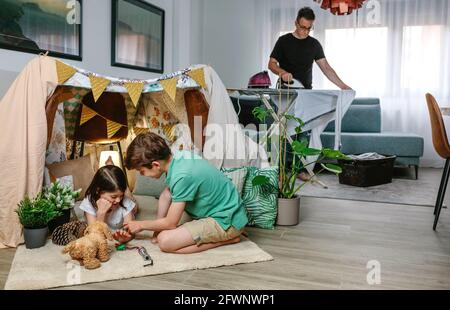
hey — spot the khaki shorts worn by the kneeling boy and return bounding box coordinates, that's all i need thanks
[181,217,244,245]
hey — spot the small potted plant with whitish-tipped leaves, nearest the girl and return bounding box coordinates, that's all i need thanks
[42,181,81,233]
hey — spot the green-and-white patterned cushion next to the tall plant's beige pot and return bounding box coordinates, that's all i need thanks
[242,167,278,229]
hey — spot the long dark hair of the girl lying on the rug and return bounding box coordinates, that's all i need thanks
[86,165,127,208]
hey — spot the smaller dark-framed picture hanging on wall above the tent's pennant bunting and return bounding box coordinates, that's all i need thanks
[111,0,164,73]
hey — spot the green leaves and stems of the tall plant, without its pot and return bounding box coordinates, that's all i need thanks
[252,107,349,199]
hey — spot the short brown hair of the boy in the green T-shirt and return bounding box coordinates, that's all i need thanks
[125,132,172,170]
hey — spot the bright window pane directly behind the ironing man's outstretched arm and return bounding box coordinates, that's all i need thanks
[323,27,388,95]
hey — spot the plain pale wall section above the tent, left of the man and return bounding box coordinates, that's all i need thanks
[191,0,264,87]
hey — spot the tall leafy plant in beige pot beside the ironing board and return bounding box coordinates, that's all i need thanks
[252,107,349,226]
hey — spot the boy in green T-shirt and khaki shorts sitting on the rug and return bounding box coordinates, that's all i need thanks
[124,133,248,254]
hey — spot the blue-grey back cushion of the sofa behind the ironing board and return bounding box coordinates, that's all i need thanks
[325,98,381,132]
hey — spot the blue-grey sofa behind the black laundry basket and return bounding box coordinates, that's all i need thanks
[321,98,424,179]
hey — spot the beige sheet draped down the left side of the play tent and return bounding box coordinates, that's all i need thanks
[0,56,58,248]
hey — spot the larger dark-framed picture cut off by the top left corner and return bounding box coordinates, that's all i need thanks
[0,0,82,60]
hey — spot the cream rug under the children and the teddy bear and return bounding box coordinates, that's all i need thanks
[5,237,273,290]
